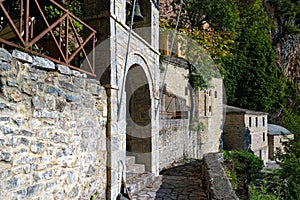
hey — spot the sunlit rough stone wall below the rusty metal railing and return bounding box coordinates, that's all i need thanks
[0,49,107,199]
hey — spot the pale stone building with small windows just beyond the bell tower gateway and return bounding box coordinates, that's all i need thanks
[159,54,223,170]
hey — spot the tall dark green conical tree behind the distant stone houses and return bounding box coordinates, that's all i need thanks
[223,0,286,112]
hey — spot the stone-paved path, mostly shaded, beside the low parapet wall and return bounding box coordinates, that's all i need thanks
[133,160,207,200]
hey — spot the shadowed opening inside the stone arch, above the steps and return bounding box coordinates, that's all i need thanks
[125,65,152,171]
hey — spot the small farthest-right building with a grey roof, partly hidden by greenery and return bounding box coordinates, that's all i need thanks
[268,124,294,160]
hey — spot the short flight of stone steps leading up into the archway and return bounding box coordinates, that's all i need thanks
[126,156,155,195]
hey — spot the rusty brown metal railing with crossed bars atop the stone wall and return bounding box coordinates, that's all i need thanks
[0,0,96,76]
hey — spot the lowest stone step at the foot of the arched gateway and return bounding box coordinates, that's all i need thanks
[126,172,155,195]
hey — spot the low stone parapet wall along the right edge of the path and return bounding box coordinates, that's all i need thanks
[202,153,238,200]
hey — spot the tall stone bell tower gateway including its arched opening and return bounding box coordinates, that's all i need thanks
[84,0,159,199]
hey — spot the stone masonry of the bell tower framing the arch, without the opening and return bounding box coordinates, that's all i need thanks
[84,0,159,199]
